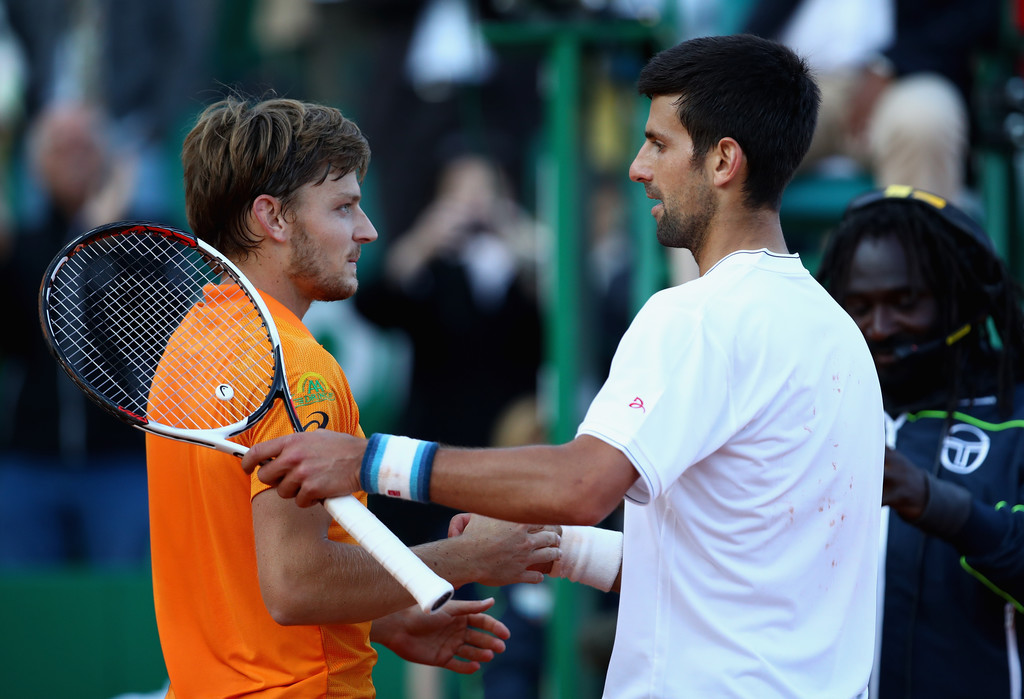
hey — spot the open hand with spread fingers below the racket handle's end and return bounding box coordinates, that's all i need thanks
[370,598,511,674]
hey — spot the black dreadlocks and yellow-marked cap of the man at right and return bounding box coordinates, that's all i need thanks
[817,187,1024,414]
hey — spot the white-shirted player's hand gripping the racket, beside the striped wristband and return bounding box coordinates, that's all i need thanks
[242,430,367,508]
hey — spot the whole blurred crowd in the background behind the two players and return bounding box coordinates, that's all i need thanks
[0,0,1004,699]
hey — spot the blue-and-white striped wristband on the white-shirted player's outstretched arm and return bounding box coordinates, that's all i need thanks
[359,434,437,503]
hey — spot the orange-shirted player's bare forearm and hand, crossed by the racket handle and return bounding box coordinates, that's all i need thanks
[253,491,559,624]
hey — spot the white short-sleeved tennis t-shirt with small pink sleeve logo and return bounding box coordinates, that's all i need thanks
[579,250,884,699]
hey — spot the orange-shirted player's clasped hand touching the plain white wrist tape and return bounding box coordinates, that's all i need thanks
[449,513,561,587]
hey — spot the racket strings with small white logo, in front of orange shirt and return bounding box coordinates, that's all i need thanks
[46,231,275,429]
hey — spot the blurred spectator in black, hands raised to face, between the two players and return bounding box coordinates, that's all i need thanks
[353,146,544,699]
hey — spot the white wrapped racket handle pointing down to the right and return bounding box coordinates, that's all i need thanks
[324,495,455,614]
